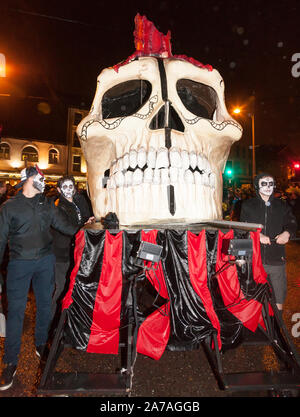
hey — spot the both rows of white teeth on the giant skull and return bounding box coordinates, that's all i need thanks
[104,148,216,189]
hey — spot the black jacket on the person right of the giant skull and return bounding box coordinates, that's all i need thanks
[240,194,297,265]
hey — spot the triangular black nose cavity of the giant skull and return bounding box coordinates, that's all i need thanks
[149,101,184,132]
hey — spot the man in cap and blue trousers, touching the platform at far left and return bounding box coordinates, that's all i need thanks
[0,166,78,391]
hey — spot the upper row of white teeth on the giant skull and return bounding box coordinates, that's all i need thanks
[110,148,212,175]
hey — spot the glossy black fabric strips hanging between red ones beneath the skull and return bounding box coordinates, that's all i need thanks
[65,229,268,350]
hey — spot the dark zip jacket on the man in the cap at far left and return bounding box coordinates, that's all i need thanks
[0,192,78,262]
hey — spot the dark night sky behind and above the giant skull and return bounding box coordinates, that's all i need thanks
[0,0,300,149]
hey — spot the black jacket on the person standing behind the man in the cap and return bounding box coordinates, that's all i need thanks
[52,193,92,262]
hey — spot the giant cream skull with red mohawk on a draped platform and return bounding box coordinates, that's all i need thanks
[77,15,242,226]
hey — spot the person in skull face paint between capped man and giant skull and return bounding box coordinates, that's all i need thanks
[52,176,94,330]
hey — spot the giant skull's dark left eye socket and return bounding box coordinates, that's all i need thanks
[102,80,152,119]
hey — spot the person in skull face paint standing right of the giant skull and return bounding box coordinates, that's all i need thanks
[240,173,297,312]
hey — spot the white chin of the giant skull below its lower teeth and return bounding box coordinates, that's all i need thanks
[104,183,222,226]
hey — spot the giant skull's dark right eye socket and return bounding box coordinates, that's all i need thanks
[176,79,217,120]
